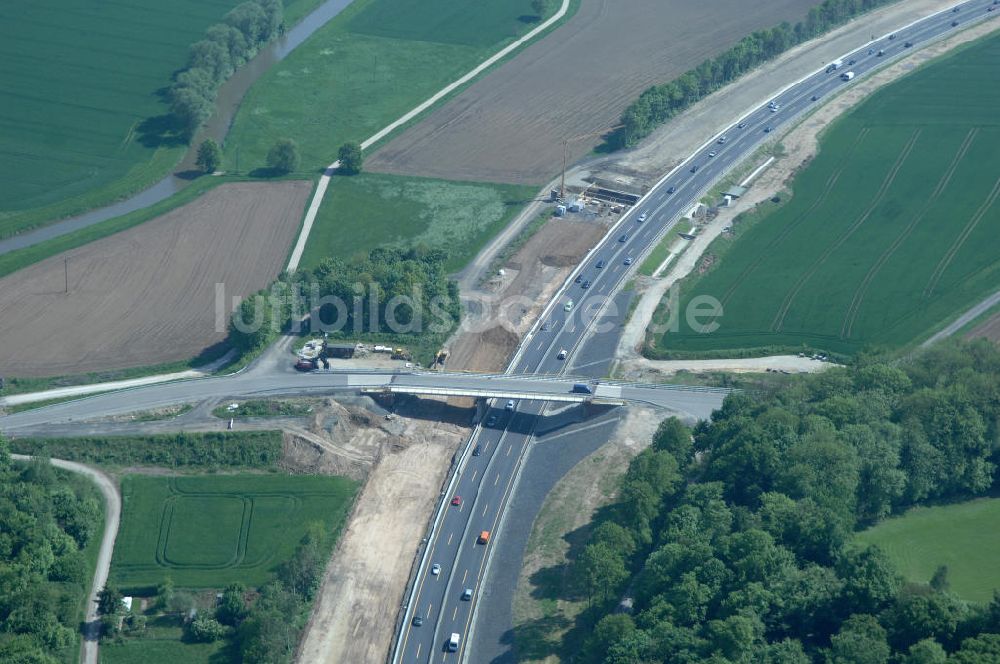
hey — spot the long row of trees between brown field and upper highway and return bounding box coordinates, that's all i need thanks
[612,0,895,147]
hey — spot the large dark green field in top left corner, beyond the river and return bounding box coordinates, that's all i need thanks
[0,0,319,237]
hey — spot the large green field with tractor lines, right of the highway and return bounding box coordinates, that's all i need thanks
[647,36,1000,357]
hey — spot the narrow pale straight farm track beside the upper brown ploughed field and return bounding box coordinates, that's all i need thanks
[285,0,570,272]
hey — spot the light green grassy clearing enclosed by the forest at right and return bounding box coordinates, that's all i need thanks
[857,498,1000,602]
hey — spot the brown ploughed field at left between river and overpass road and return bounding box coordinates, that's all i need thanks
[0,182,312,377]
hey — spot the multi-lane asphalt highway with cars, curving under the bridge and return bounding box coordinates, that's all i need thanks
[392,0,1000,664]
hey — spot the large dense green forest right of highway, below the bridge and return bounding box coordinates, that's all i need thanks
[566,341,1000,664]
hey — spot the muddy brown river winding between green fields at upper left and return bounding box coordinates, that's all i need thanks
[0,0,351,254]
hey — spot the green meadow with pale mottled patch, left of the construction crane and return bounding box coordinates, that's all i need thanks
[302,173,537,270]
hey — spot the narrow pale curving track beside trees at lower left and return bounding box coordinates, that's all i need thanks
[11,454,122,664]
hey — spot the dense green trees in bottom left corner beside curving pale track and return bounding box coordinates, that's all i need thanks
[0,438,103,664]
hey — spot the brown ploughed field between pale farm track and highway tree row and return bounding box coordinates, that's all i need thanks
[365,0,815,184]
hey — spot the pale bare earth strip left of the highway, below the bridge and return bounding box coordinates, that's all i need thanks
[296,400,472,664]
